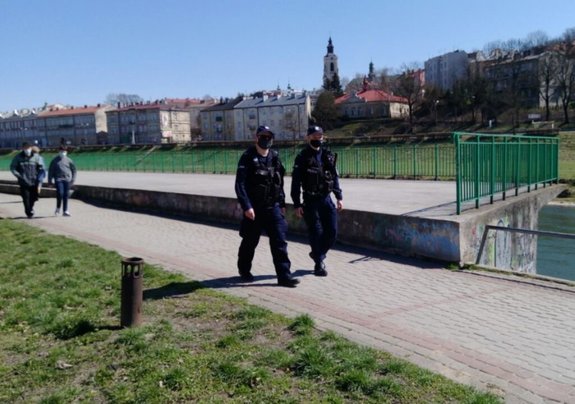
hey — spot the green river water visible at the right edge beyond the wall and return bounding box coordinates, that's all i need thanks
[537,205,575,280]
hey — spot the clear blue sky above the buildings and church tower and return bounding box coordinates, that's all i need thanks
[0,0,575,111]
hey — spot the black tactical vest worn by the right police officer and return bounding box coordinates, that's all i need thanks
[302,150,336,197]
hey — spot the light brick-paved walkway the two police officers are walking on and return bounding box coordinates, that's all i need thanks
[0,175,575,403]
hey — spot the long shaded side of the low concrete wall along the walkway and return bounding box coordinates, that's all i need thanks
[74,186,459,262]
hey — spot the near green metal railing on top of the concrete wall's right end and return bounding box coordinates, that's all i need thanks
[453,132,559,214]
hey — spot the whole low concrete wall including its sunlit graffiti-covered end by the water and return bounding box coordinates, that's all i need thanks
[0,179,565,273]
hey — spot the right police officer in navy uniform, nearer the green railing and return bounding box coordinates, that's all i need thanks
[291,126,343,276]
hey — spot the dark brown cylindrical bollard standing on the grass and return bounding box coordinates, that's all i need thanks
[120,257,144,327]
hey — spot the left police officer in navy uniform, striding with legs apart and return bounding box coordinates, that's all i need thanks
[236,126,299,288]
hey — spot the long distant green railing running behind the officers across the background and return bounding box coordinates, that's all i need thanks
[0,143,455,180]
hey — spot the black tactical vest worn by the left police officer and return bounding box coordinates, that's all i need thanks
[247,150,282,207]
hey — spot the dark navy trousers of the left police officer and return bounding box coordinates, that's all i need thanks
[238,205,291,279]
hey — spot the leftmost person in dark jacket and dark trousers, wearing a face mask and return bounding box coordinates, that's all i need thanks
[10,142,45,218]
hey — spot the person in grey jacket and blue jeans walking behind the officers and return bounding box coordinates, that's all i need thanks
[48,146,76,216]
